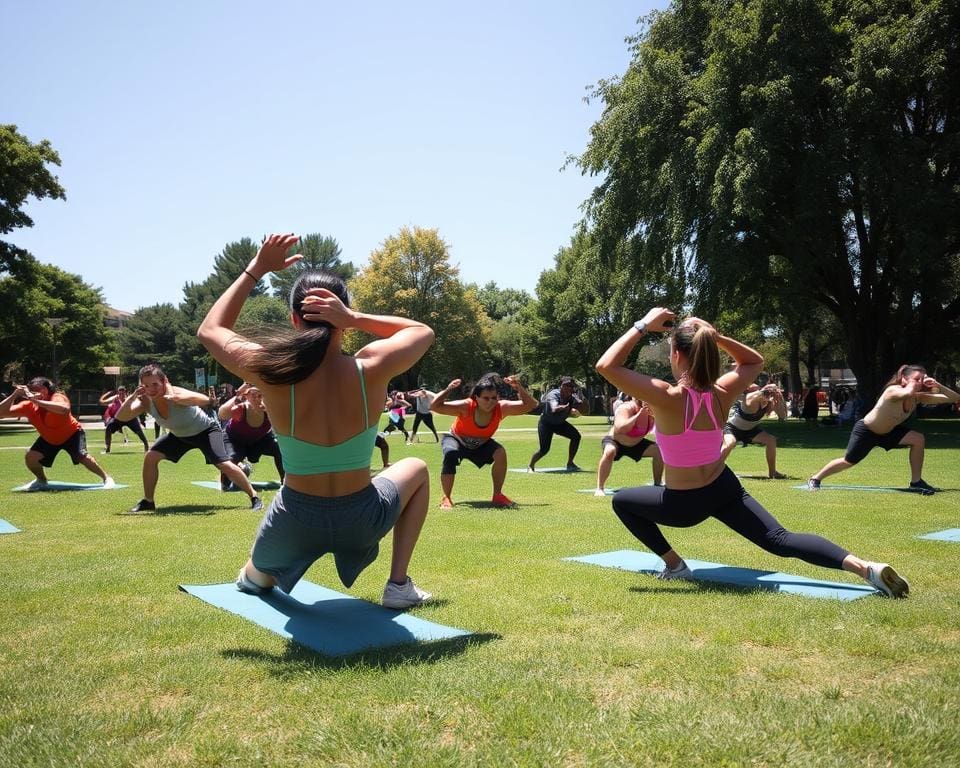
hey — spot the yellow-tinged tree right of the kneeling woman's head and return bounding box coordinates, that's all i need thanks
[350,227,490,389]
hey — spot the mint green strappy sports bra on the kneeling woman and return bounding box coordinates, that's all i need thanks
[277,359,377,475]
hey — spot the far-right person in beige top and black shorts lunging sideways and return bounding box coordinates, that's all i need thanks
[807,365,960,496]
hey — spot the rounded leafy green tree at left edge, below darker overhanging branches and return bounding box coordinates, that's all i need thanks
[0,257,112,388]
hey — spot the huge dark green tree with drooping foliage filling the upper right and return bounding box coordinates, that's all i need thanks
[580,0,960,399]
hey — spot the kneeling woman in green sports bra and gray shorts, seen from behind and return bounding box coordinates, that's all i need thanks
[197,235,433,608]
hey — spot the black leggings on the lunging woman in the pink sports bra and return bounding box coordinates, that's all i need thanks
[613,467,850,569]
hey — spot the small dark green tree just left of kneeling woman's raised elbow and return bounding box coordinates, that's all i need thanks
[120,303,193,386]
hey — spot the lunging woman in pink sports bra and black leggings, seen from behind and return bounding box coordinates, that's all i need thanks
[596,307,910,597]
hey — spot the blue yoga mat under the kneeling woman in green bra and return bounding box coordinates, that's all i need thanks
[180,581,472,656]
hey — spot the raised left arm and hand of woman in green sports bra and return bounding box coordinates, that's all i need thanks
[197,235,303,379]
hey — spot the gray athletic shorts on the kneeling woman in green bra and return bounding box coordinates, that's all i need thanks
[250,477,400,592]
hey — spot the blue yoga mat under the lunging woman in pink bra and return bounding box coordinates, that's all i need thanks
[564,549,877,600]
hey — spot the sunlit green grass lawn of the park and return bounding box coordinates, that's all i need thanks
[0,417,960,768]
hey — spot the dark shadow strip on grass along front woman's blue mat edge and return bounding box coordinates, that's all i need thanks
[220,632,500,678]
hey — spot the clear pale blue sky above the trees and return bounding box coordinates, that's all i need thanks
[0,0,664,311]
